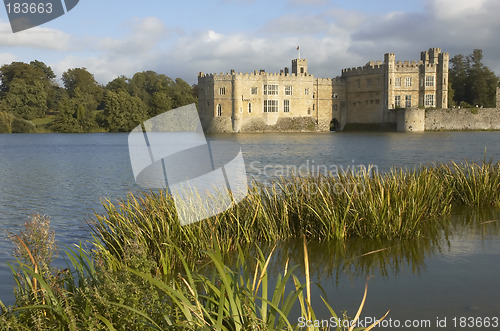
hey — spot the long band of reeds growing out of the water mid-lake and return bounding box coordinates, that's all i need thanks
[89,161,500,273]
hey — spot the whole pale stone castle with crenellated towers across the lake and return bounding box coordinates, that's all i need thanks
[198,48,449,132]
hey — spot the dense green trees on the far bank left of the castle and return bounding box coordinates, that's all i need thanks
[0,61,197,133]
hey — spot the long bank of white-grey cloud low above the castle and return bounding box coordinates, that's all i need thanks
[45,0,500,87]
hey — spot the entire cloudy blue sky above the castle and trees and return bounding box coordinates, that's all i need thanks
[0,0,500,84]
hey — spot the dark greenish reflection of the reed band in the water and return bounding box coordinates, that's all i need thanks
[229,207,500,286]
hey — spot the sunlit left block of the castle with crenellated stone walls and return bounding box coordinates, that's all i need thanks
[198,65,333,132]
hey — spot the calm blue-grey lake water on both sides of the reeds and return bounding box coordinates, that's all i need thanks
[0,132,500,326]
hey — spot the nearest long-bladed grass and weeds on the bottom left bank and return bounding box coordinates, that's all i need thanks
[0,218,389,331]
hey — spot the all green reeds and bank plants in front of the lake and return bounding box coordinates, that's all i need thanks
[0,161,500,330]
